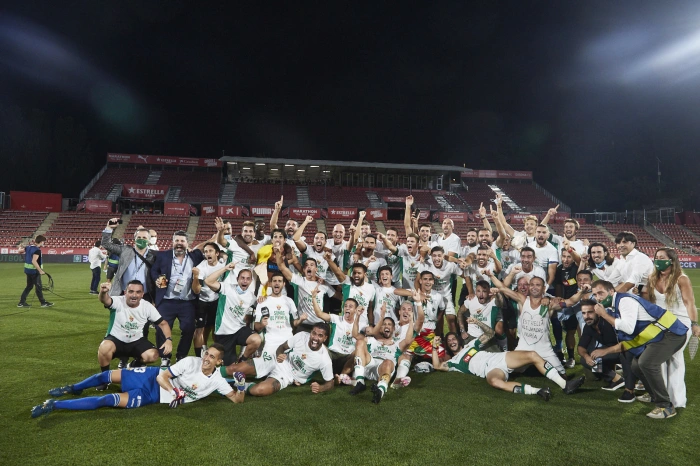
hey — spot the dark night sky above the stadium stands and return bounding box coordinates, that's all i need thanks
[0,0,700,211]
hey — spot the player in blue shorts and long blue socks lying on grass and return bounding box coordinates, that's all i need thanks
[32,343,245,417]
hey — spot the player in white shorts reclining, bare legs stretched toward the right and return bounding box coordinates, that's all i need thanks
[433,317,586,401]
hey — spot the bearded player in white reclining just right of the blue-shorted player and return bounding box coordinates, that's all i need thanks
[231,322,333,401]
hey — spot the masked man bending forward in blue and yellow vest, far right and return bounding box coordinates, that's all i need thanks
[591,280,688,419]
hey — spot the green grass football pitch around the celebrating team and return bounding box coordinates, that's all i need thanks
[0,264,700,466]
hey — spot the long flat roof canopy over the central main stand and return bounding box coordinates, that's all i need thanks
[219,156,470,179]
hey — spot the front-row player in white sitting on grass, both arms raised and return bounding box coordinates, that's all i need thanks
[350,303,413,403]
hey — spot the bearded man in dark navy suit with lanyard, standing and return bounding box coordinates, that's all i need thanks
[151,231,204,366]
